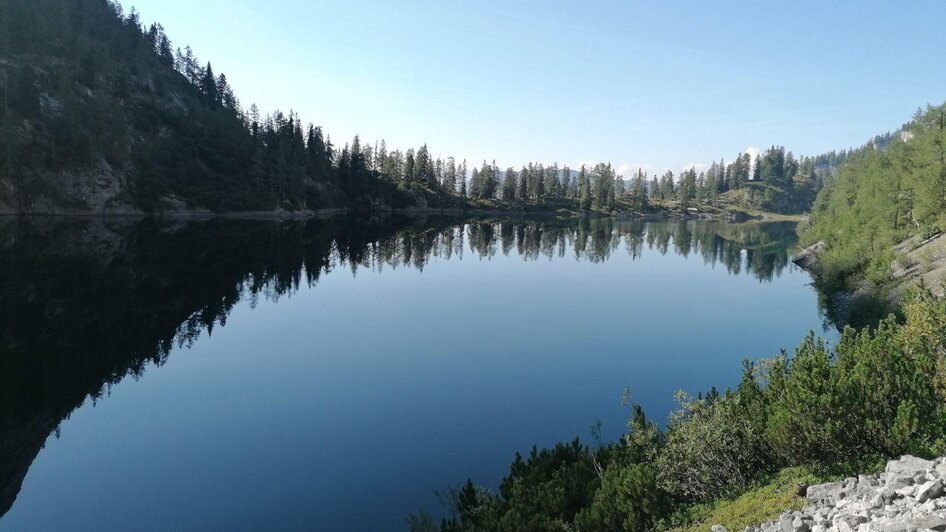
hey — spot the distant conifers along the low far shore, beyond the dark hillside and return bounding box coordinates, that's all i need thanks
[452,146,824,212]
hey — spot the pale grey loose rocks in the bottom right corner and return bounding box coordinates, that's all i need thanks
[732,456,946,532]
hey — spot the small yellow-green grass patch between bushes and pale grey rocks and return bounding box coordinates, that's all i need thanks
[674,466,826,532]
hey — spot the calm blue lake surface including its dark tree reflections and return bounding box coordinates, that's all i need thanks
[0,214,822,530]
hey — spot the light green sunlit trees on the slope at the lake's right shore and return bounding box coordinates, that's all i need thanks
[803,101,946,296]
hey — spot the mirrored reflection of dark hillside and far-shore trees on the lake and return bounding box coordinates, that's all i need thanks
[0,214,795,516]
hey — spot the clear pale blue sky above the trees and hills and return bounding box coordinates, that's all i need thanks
[122,0,946,172]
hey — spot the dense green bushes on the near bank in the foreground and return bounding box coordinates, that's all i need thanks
[408,294,946,531]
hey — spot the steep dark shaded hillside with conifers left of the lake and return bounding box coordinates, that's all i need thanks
[0,0,454,214]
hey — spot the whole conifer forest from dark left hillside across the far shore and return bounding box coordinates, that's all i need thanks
[0,0,828,213]
